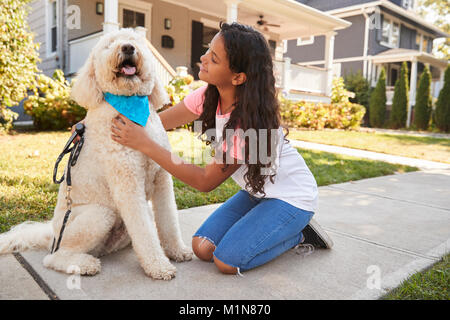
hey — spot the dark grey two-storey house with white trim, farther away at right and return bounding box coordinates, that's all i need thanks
[287,0,450,127]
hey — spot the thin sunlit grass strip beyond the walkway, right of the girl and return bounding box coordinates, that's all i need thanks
[288,129,450,163]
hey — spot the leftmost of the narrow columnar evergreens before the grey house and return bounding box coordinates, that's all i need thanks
[369,68,386,128]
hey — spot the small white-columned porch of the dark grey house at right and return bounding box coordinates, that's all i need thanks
[370,48,448,127]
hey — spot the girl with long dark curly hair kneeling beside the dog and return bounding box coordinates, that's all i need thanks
[111,23,332,274]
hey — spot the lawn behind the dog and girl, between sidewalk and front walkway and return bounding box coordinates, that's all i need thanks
[0,130,417,233]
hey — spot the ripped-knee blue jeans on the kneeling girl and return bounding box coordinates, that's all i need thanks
[193,190,314,271]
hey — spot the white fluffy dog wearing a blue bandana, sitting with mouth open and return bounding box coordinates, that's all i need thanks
[0,29,192,280]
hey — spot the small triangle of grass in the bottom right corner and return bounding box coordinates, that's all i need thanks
[381,254,450,300]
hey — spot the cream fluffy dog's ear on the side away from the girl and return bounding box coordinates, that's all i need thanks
[71,52,103,109]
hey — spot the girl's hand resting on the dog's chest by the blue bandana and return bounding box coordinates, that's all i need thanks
[111,114,150,152]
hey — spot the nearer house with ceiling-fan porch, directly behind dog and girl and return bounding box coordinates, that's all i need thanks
[13,0,351,124]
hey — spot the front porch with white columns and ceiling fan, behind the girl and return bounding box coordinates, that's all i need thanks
[66,0,350,102]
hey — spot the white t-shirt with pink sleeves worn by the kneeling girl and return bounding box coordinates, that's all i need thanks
[183,86,319,212]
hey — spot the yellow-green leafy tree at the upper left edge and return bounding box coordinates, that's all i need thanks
[0,0,39,131]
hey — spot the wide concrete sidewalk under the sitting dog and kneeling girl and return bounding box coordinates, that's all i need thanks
[0,169,450,300]
